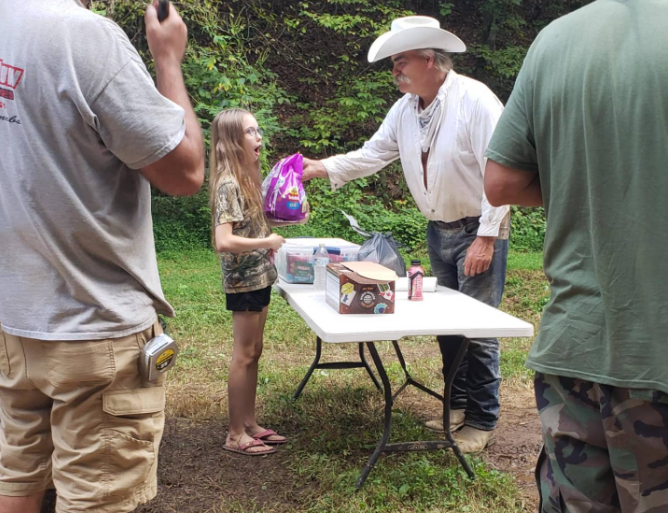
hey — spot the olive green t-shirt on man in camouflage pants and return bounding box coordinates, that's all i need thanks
[487,0,668,392]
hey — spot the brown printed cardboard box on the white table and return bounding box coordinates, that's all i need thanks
[325,262,397,314]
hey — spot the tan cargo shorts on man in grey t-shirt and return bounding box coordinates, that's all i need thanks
[0,322,165,513]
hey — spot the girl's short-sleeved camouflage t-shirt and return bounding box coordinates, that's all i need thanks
[216,178,278,294]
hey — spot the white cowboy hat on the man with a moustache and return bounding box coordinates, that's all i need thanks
[369,16,466,62]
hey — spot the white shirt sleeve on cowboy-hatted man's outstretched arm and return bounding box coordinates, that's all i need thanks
[322,102,399,191]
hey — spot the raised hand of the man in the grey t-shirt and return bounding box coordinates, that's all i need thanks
[144,2,188,66]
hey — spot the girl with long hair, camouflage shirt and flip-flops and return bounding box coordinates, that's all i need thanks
[209,109,287,456]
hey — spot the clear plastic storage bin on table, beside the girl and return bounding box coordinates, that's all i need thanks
[274,238,360,283]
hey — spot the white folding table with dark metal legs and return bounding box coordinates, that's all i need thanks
[274,280,533,489]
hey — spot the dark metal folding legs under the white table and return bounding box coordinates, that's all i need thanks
[292,337,475,490]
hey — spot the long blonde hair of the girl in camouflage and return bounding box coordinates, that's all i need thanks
[209,109,267,247]
